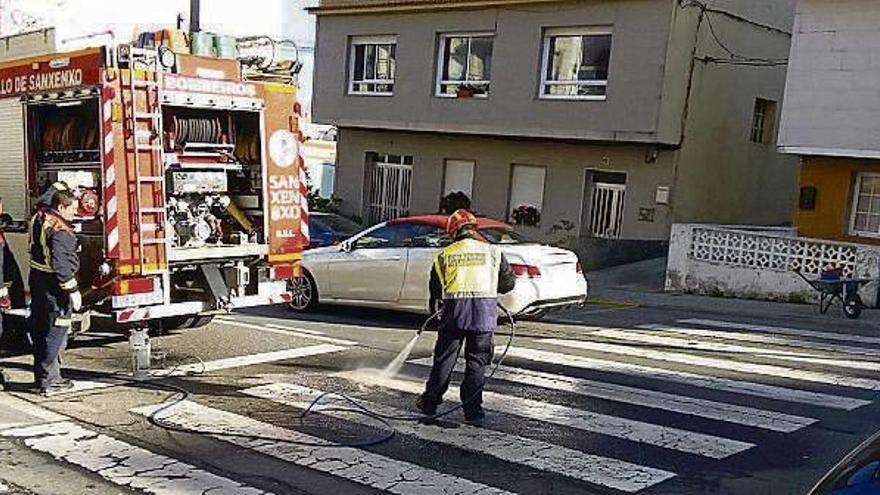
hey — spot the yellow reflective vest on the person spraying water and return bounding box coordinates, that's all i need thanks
[434,239,501,299]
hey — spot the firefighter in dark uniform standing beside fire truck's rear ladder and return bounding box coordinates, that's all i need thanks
[29,188,82,395]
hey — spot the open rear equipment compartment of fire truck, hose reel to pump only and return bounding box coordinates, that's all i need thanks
[163,106,265,252]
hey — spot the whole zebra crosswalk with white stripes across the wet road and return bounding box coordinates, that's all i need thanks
[0,319,880,495]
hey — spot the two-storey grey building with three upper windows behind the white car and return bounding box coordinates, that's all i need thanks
[312,0,797,266]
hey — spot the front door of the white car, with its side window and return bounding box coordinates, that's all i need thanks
[328,224,413,302]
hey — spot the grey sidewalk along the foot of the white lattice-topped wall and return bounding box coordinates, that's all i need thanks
[566,258,880,331]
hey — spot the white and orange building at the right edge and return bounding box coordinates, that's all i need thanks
[779,0,880,244]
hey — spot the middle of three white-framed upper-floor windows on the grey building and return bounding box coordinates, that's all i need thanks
[437,33,494,98]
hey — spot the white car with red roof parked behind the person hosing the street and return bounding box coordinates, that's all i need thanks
[290,215,587,316]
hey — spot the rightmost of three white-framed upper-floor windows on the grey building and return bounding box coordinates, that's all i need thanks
[541,28,611,100]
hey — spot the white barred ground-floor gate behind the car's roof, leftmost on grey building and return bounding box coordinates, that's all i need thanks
[370,162,412,224]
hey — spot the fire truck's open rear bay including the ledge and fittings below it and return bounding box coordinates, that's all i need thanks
[162,105,268,309]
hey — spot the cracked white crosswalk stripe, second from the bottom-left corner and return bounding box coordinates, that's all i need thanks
[133,401,508,495]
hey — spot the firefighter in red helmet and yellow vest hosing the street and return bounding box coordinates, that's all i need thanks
[416,210,516,423]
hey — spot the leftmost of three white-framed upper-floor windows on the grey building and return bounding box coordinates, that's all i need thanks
[348,36,397,96]
